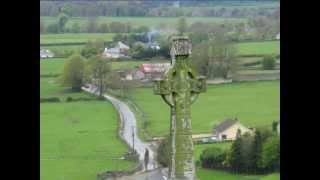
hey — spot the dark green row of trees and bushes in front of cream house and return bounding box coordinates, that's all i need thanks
[200,129,280,174]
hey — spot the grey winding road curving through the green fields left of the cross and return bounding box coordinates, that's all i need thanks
[82,85,157,170]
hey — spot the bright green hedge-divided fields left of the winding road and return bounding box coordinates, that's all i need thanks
[40,59,136,180]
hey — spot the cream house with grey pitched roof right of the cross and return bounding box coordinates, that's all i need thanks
[213,118,252,141]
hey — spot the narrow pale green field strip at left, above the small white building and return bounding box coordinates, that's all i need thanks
[40,33,114,44]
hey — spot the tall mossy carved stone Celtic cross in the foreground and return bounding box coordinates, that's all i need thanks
[154,36,206,180]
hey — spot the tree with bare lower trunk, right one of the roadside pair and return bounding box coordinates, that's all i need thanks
[87,55,111,98]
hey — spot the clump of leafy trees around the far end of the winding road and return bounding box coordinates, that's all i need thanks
[59,40,136,99]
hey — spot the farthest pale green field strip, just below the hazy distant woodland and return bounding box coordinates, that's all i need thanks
[40,16,247,27]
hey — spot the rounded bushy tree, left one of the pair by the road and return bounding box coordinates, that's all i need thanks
[60,54,84,91]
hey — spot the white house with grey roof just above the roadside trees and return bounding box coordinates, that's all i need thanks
[103,41,130,58]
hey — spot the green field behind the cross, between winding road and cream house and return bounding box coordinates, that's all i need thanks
[131,81,280,136]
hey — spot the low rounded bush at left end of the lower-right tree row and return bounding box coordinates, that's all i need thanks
[200,147,226,168]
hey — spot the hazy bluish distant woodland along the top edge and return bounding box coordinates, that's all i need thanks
[40,1,278,17]
